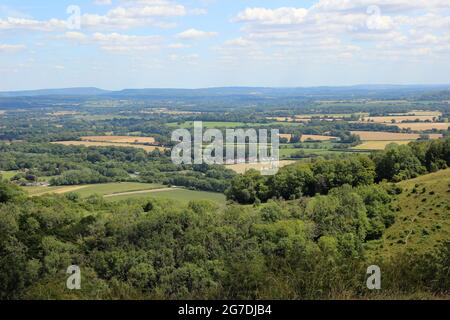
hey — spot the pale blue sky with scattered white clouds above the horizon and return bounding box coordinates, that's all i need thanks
[0,0,450,91]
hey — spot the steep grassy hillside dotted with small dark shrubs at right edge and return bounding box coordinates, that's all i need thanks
[371,169,450,256]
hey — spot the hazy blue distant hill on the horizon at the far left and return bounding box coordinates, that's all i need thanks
[0,87,110,98]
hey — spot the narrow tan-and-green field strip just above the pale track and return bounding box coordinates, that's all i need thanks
[23,182,165,197]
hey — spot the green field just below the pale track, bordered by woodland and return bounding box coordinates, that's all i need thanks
[107,189,226,204]
